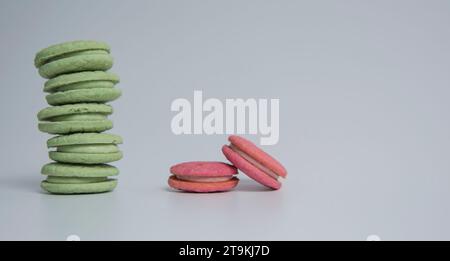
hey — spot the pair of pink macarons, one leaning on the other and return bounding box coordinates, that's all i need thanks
[168,135,287,193]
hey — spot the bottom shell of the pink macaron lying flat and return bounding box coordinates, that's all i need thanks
[168,175,239,193]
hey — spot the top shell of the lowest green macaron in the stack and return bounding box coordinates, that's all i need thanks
[41,162,119,178]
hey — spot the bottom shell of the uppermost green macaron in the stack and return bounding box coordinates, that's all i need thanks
[39,54,113,79]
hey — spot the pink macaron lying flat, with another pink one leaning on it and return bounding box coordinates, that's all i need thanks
[168,161,239,192]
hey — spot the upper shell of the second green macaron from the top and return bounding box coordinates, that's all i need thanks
[44,71,120,92]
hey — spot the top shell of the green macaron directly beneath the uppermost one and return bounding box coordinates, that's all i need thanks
[44,71,120,93]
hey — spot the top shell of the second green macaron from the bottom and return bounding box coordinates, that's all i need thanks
[47,133,122,148]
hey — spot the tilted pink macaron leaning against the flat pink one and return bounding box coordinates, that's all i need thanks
[222,135,287,189]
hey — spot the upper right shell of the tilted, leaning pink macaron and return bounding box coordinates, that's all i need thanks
[228,135,287,178]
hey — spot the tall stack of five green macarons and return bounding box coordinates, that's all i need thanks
[34,41,122,194]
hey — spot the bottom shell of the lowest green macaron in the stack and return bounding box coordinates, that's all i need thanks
[41,179,117,194]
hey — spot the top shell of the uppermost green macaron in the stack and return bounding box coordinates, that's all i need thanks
[34,40,110,68]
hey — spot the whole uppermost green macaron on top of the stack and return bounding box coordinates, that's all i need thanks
[34,41,113,79]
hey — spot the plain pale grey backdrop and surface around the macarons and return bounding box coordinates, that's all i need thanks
[0,0,450,240]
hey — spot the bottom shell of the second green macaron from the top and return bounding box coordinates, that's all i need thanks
[45,88,122,105]
